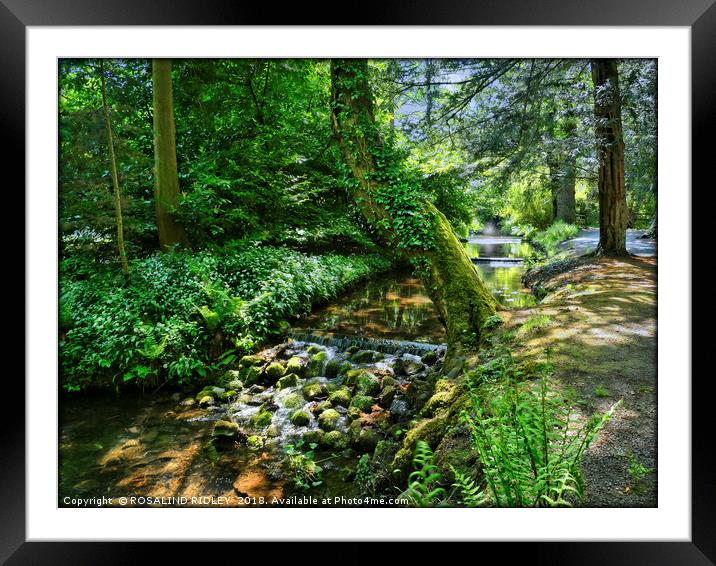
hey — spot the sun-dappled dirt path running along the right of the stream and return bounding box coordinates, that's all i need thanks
[501,257,657,507]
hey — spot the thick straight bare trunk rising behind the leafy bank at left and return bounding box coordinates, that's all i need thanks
[152,59,189,251]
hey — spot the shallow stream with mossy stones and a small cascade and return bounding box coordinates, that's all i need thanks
[58,236,534,507]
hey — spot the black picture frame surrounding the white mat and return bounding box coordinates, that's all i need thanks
[5,0,716,566]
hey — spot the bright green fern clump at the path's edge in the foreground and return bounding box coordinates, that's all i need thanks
[455,365,621,507]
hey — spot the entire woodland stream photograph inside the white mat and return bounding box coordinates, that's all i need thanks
[57,59,657,508]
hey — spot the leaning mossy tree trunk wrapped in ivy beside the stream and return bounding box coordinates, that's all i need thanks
[331,59,497,359]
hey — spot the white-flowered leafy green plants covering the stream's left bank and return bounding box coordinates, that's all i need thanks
[60,247,389,389]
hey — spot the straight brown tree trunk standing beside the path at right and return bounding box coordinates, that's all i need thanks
[591,59,628,256]
